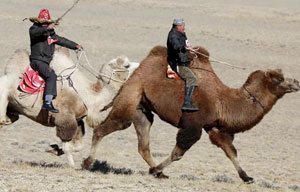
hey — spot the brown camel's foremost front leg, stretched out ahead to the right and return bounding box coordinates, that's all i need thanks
[208,127,254,183]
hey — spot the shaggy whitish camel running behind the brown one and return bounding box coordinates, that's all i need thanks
[0,48,134,166]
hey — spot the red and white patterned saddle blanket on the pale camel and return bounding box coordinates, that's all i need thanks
[19,65,45,93]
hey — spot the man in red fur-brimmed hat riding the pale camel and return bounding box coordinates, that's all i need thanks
[29,9,82,113]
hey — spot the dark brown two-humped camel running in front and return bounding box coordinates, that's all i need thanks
[83,46,300,183]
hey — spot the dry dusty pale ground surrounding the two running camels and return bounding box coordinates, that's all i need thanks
[0,0,300,192]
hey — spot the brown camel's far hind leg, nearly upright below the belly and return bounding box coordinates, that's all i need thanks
[133,110,156,167]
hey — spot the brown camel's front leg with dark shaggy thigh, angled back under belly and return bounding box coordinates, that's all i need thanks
[149,128,202,178]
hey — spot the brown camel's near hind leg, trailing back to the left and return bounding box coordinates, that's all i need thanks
[82,79,142,169]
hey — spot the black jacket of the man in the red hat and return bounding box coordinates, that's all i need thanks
[29,23,77,64]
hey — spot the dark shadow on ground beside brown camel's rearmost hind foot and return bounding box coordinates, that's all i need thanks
[89,160,134,175]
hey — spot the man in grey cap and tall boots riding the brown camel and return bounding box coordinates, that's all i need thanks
[167,18,199,111]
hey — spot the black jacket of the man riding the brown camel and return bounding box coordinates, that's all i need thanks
[167,28,190,70]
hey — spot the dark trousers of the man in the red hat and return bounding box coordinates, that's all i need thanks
[30,60,57,97]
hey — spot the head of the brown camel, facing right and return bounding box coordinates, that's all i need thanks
[265,69,300,97]
